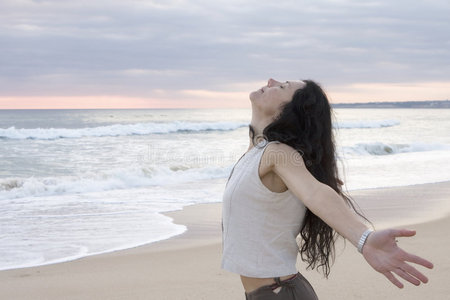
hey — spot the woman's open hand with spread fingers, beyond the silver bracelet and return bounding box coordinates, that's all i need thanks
[363,229,433,288]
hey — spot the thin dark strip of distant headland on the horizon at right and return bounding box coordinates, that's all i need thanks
[331,100,450,108]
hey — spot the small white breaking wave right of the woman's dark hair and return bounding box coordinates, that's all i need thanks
[341,142,450,155]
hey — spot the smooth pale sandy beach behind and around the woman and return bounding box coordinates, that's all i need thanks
[0,182,450,300]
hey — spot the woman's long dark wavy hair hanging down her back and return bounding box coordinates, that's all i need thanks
[250,80,365,277]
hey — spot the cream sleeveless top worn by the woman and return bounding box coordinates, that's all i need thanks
[222,140,306,278]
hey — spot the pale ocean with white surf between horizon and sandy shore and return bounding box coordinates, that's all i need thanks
[0,109,450,270]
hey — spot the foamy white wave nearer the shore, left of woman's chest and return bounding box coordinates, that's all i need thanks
[0,166,231,200]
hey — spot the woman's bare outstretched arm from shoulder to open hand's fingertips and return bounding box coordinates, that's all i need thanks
[266,144,433,288]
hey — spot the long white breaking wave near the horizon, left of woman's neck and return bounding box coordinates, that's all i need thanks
[0,121,248,140]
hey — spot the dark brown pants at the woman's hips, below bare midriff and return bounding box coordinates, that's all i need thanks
[245,273,319,300]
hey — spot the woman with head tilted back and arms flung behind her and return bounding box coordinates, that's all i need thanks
[222,79,433,299]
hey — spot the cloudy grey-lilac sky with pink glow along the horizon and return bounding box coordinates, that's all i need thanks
[0,0,450,109]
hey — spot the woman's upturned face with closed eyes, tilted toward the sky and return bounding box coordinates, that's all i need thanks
[250,78,305,117]
